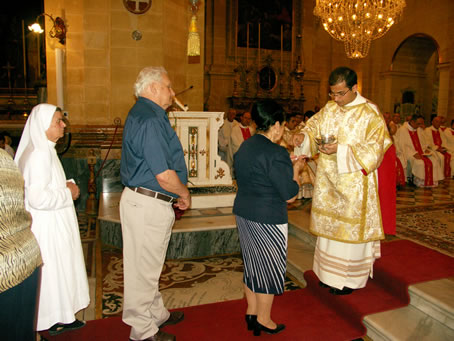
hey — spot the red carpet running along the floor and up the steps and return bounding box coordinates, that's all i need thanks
[43,240,454,341]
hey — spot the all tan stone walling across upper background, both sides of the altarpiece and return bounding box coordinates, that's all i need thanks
[41,0,454,125]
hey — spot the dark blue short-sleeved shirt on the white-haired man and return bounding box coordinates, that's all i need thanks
[120,97,188,197]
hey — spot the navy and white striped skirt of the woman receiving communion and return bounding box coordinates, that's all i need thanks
[236,216,288,295]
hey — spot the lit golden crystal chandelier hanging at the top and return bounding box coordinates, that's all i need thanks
[314,0,405,59]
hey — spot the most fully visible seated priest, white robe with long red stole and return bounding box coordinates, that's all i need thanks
[394,115,444,187]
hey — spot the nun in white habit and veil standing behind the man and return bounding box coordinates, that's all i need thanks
[15,104,90,335]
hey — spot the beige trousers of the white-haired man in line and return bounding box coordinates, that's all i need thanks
[120,187,175,340]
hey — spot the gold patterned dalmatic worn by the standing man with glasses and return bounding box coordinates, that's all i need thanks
[304,101,392,243]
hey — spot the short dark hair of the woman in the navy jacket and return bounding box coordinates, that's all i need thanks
[251,99,285,131]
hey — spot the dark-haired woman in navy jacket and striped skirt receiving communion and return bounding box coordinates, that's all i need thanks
[233,100,304,336]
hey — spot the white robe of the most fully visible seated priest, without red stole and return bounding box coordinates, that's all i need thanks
[394,122,444,187]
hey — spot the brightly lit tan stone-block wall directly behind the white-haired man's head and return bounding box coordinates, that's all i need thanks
[44,0,205,124]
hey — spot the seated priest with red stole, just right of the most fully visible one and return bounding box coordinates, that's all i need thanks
[424,116,454,179]
